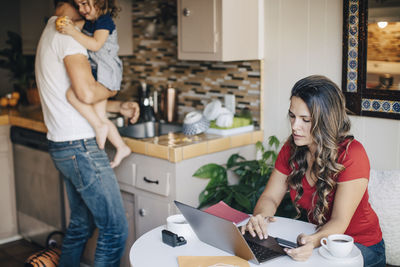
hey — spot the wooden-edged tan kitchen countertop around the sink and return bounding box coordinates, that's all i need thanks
[0,107,263,162]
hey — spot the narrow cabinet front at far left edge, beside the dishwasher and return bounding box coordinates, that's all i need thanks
[0,125,18,239]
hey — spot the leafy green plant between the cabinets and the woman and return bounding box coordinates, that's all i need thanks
[193,136,297,218]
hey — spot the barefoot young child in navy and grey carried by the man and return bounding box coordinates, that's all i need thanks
[56,0,131,168]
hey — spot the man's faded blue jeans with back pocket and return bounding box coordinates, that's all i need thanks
[49,138,128,267]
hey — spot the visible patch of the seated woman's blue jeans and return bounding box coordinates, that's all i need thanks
[355,239,386,267]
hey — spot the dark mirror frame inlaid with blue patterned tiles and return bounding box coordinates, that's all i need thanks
[342,0,400,119]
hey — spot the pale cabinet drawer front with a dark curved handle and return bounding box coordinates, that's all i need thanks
[136,169,171,196]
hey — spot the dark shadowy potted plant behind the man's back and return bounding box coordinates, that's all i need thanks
[0,31,39,104]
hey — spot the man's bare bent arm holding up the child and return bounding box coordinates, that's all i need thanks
[64,54,117,104]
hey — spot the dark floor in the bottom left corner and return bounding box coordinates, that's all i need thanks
[0,239,43,267]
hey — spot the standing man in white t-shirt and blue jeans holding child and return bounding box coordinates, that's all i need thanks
[35,3,139,267]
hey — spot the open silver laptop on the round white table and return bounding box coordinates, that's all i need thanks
[174,200,286,264]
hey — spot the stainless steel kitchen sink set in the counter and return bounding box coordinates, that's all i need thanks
[118,121,182,139]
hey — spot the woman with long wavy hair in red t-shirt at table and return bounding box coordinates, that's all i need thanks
[242,76,386,266]
